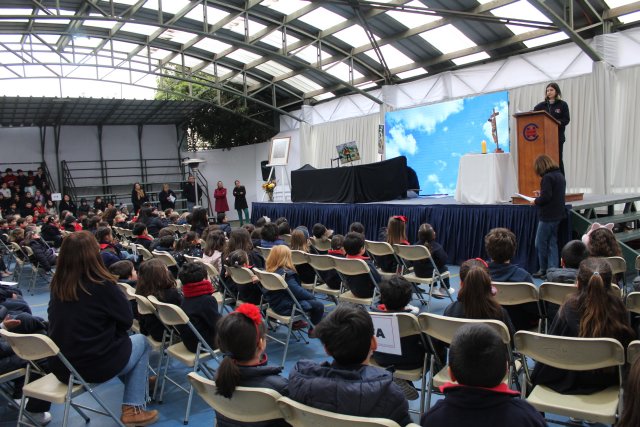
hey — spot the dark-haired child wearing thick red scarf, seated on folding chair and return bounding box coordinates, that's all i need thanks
[178,262,222,353]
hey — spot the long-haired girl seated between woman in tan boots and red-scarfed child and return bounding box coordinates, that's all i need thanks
[136,258,182,341]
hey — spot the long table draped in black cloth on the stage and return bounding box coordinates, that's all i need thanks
[291,156,407,203]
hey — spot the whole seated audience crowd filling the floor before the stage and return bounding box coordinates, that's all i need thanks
[0,174,640,427]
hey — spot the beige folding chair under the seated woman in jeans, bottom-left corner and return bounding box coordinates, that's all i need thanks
[0,329,124,427]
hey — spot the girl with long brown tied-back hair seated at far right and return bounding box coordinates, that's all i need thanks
[532,258,636,394]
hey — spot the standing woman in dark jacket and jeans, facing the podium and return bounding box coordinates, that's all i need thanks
[533,154,567,279]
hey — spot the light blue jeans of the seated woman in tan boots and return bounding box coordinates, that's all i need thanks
[118,334,151,406]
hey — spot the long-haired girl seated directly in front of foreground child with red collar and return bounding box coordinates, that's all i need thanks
[444,259,515,338]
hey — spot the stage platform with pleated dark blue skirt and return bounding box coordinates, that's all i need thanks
[251,194,640,273]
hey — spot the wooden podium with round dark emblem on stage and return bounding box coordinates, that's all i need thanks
[513,111,560,197]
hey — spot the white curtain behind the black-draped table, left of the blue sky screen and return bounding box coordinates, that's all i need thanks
[300,113,381,168]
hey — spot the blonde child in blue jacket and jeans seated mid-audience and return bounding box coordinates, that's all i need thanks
[263,245,324,334]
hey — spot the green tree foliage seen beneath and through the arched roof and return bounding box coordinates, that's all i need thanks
[156,70,277,151]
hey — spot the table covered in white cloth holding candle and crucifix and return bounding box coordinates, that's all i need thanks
[455,153,520,205]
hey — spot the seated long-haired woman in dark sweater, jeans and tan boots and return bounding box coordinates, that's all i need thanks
[48,231,158,426]
